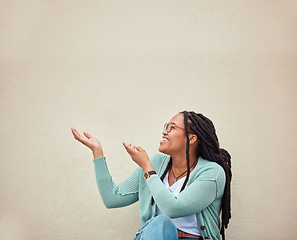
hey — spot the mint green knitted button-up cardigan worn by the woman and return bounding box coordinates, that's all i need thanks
[94,153,226,240]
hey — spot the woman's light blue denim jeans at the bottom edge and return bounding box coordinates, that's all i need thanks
[134,215,197,240]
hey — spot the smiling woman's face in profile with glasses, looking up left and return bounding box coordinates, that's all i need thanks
[159,113,187,156]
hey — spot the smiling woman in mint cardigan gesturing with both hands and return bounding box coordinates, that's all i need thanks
[72,111,231,240]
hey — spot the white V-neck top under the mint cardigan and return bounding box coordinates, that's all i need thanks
[156,172,201,236]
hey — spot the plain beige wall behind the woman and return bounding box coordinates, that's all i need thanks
[0,0,297,240]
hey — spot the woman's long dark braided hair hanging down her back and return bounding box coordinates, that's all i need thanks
[152,111,232,240]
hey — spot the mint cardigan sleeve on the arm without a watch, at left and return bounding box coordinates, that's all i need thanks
[93,157,139,208]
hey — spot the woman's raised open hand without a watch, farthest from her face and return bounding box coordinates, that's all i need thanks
[71,128,104,158]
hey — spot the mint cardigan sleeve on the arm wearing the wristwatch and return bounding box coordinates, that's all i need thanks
[146,165,225,218]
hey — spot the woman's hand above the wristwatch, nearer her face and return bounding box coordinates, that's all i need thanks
[123,142,154,172]
